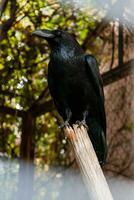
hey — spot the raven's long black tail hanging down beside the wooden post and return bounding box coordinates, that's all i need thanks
[87,120,107,166]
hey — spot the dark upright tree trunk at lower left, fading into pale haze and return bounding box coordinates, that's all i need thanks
[16,112,36,200]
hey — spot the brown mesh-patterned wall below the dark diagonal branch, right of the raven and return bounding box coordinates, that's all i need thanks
[104,73,134,178]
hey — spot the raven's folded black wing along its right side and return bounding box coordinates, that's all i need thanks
[85,55,106,136]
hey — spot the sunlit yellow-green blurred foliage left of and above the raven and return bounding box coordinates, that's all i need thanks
[0,0,107,164]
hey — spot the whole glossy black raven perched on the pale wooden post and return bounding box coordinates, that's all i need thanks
[33,30,107,164]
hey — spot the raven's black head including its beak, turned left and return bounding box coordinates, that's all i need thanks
[32,29,81,53]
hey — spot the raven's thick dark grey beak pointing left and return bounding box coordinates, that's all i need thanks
[32,29,55,39]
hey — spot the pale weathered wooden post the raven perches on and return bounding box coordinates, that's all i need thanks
[64,125,113,200]
